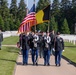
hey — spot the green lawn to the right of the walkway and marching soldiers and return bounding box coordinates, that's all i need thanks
[63,42,76,63]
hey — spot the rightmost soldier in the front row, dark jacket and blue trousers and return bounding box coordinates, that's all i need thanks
[55,33,64,66]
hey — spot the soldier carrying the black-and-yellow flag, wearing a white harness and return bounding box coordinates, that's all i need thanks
[44,33,51,66]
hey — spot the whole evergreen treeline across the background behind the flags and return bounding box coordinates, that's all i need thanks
[0,0,76,34]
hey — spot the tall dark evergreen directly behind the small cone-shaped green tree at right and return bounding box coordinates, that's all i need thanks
[59,0,73,31]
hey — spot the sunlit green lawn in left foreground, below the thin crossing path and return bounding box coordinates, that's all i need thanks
[0,47,19,75]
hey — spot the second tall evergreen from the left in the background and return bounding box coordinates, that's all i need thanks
[10,0,17,20]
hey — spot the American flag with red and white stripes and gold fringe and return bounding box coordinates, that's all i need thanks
[18,4,36,33]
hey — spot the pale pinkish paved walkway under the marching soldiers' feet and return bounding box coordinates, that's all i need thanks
[14,55,76,75]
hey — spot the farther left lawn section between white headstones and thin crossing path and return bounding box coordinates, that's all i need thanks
[2,36,19,45]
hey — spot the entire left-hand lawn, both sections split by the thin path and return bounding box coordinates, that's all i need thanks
[0,36,19,75]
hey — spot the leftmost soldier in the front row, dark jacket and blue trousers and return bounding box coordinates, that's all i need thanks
[22,34,29,65]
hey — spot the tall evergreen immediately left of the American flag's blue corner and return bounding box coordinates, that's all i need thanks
[17,0,26,22]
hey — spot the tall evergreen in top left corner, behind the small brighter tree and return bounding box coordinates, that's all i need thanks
[0,0,9,30]
